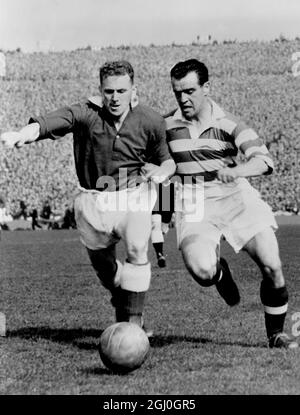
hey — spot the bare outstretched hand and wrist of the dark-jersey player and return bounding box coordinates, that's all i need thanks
[1,122,40,148]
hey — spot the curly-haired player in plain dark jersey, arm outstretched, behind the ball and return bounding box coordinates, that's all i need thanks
[1,61,175,338]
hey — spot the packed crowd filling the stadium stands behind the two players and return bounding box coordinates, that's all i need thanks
[0,39,300,227]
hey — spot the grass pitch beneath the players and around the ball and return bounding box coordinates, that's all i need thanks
[0,226,300,395]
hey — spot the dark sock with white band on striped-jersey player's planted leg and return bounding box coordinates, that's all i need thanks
[260,280,288,338]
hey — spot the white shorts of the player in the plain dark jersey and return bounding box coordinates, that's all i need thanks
[74,182,157,250]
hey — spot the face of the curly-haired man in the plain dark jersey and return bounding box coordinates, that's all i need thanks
[100,74,134,118]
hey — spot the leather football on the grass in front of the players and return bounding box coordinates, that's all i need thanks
[99,322,150,373]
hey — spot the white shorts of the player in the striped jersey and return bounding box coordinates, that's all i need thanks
[175,179,278,252]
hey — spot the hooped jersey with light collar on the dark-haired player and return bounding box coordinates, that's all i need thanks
[165,99,274,182]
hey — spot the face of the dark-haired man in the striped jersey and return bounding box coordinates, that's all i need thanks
[171,72,209,120]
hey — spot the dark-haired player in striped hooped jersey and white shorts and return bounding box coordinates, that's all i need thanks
[166,59,298,348]
